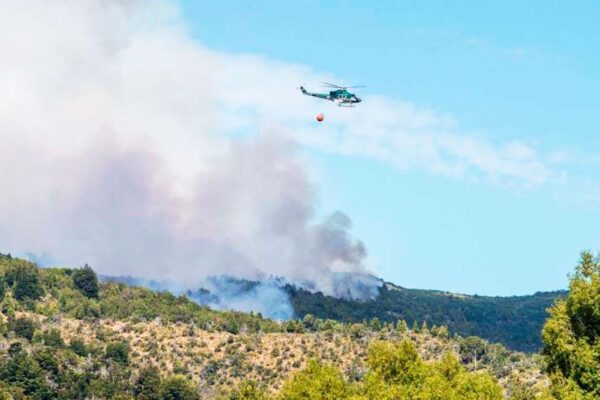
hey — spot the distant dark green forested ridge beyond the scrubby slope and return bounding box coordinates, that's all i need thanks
[286,283,567,352]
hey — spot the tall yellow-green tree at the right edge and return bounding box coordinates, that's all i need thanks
[542,252,600,399]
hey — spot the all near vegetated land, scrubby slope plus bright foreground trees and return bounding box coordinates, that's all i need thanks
[0,253,600,400]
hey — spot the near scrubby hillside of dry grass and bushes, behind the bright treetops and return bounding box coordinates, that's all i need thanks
[0,255,547,399]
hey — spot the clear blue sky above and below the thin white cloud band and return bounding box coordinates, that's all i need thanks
[182,1,600,295]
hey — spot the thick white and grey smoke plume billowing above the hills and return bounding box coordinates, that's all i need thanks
[0,0,375,303]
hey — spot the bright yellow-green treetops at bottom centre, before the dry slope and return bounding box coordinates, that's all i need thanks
[279,340,503,400]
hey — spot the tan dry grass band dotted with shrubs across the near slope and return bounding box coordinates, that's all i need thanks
[9,313,545,391]
